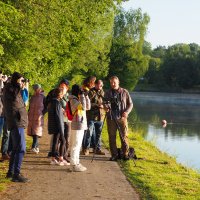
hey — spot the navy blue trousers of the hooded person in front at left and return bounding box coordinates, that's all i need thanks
[8,128,26,175]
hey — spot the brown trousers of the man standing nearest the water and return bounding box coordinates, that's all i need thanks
[107,118,129,157]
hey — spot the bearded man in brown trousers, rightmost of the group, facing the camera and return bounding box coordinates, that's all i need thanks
[105,76,133,161]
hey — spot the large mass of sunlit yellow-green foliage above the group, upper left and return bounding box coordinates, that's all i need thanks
[0,0,117,89]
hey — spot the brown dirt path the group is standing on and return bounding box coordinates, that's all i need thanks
[0,123,139,200]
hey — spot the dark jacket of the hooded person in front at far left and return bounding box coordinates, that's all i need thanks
[3,83,28,130]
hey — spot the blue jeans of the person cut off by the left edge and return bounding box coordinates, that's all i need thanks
[1,119,12,155]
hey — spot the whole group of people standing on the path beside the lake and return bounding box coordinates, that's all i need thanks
[2,72,133,182]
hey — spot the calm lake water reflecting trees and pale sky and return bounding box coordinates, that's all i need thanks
[132,92,200,170]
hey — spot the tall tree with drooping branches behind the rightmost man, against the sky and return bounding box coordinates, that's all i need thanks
[109,9,149,90]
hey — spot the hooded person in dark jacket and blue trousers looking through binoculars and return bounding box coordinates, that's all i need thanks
[3,72,29,182]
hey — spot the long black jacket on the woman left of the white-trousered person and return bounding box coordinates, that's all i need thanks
[48,98,64,135]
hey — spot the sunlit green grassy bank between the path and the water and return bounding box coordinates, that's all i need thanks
[102,127,200,200]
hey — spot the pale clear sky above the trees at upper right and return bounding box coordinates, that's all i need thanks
[122,0,200,48]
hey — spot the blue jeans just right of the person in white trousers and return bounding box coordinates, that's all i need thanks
[83,120,103,150]
